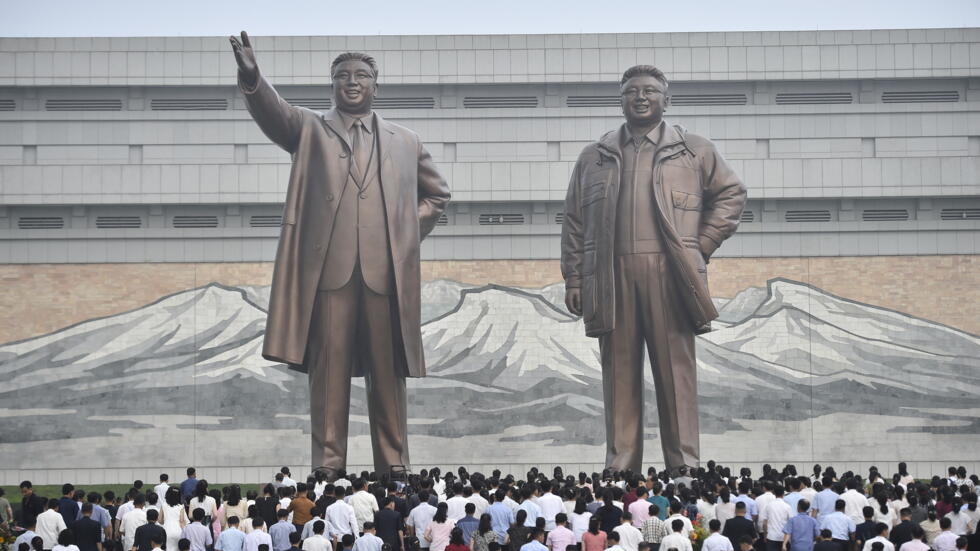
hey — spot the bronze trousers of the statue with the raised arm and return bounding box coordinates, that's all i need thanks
[305,267,409,473]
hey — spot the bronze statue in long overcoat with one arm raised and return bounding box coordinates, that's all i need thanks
[231,32,450,479]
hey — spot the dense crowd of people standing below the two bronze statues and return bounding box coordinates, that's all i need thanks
[0,461,980,551]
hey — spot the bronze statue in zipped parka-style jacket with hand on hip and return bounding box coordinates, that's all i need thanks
[561,65,746,472]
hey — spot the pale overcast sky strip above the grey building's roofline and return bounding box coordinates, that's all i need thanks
[0,0,980,36]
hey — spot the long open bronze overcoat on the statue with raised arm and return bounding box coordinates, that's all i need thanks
[239,71,450,377]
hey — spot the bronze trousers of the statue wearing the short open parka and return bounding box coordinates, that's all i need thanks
[599,253,700,472]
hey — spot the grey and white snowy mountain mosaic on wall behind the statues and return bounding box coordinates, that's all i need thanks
[0,279,980,469]
